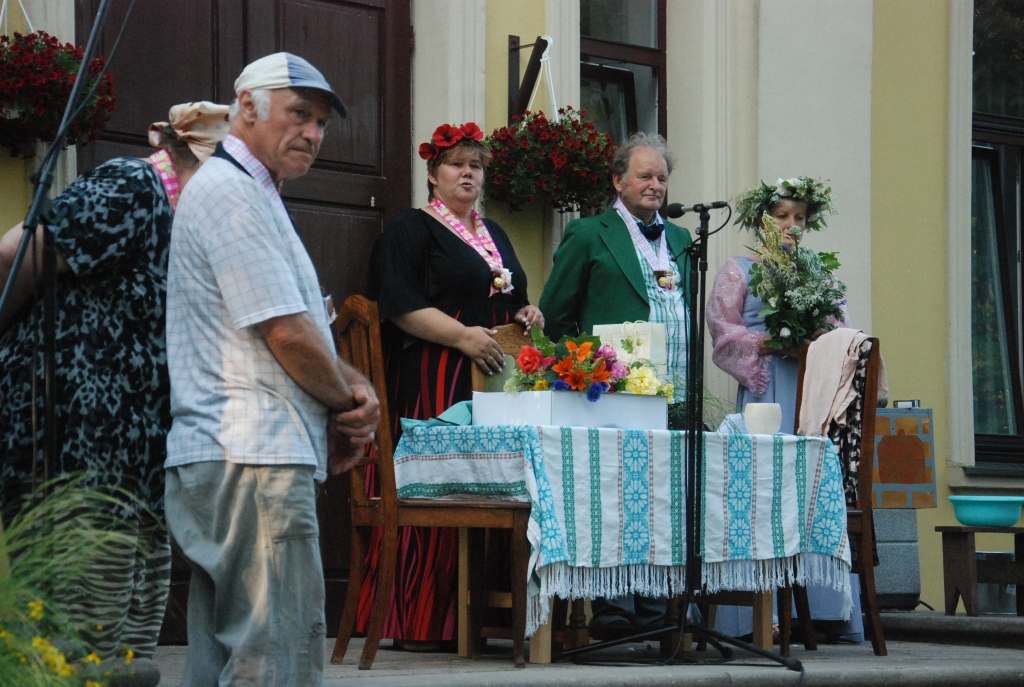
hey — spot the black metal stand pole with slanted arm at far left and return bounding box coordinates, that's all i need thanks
[0,0,111,481]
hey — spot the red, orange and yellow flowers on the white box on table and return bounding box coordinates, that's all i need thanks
[504,330,674,401]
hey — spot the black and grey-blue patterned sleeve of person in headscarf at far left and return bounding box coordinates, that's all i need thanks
[51,158,171,276]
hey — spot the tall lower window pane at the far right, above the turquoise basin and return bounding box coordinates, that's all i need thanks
[971,158,1017,434]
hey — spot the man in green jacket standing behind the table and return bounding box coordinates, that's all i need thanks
[541,133,691,630]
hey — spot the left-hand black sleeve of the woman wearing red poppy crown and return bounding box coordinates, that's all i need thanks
[368,210,433,319]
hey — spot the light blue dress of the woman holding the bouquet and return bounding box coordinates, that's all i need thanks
[715,257,864,642]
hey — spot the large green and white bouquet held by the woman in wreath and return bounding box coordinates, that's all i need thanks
[750,212,846,350]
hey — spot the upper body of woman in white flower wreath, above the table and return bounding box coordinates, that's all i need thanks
[707,176,848,434]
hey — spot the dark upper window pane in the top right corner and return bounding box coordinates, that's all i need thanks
[974,0,1024,118]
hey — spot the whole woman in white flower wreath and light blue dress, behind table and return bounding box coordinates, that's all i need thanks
[707,176,863,640]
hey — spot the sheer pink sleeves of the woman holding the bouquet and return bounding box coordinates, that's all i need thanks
[706,256,850,396]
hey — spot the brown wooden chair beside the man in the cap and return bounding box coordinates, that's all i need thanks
[331,296,529,671]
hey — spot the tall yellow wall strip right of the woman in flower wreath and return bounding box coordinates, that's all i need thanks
[871,0,1013,608]
